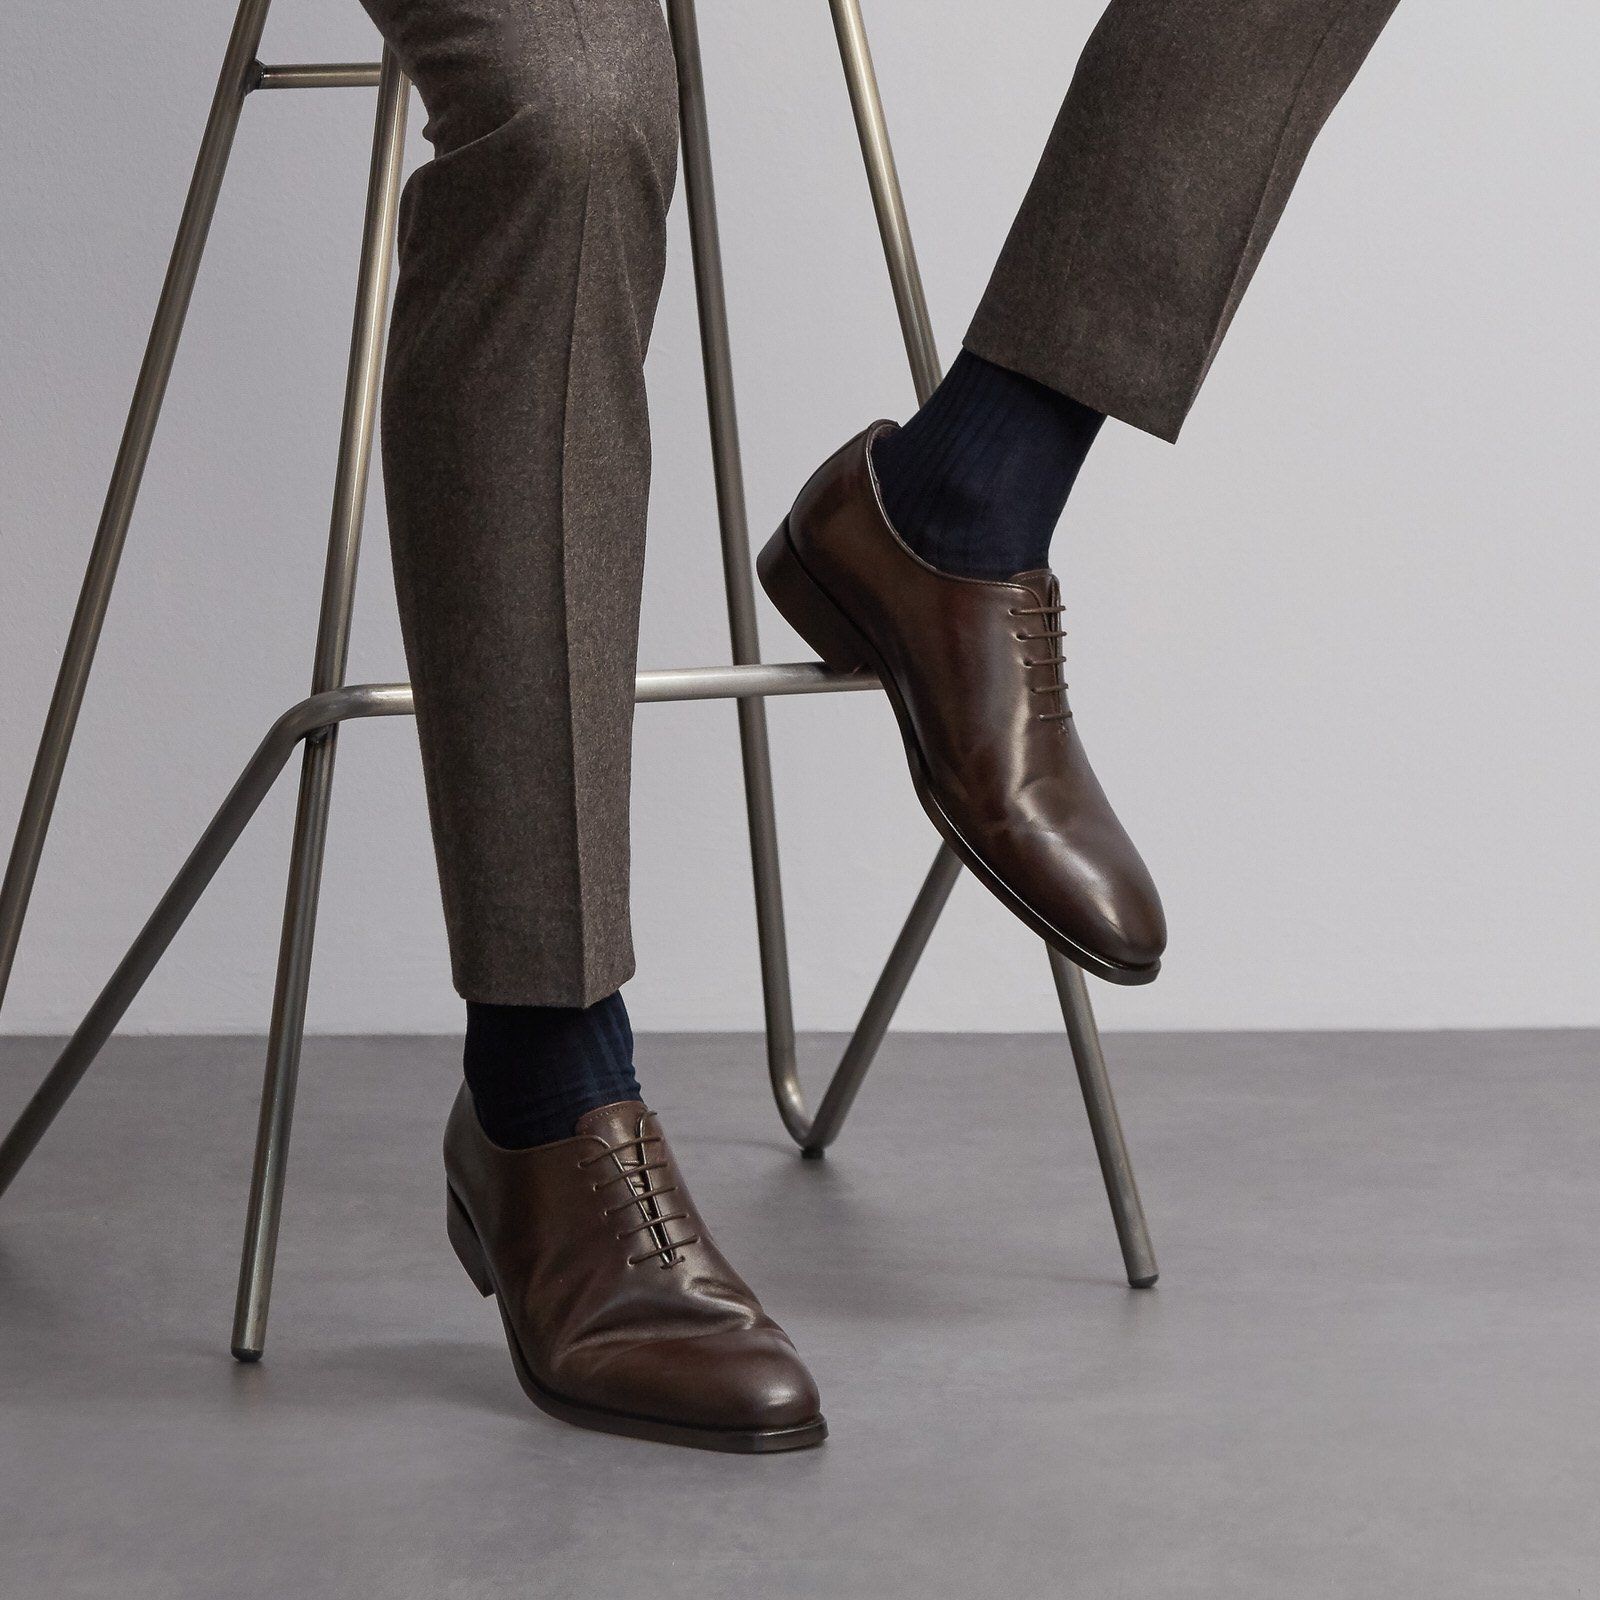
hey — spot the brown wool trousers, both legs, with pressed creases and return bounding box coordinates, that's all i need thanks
[362,0,1398,1006]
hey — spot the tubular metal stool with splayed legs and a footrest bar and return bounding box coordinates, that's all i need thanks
[0,0,1157,1362]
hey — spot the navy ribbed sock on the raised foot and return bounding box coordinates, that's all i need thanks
[872,350,1106,578]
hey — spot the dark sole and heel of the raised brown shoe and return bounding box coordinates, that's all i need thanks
[755,517,1162,987]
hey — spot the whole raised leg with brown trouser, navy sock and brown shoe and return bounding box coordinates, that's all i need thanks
[760,0,1397,982]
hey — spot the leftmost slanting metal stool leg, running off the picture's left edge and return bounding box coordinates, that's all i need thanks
[0,0,270,1002]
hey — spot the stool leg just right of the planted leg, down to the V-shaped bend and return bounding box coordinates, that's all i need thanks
[667,0,805,1131]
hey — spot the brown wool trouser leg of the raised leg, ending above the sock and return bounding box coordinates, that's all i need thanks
[965,0,1398,440]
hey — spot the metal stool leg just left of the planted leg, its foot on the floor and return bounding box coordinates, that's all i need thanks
[232,59,410,1362]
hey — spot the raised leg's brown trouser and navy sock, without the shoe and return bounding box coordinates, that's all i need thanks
[875,0,1398,578]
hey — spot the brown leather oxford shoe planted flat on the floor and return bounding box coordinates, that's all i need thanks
[445,1086,827,1454]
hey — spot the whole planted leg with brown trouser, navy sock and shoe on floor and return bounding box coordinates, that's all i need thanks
[363,0,826,1450]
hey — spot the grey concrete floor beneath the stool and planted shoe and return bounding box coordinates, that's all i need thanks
[0,1034,1600,1600]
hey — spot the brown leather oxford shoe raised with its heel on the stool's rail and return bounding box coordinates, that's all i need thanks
[757,422,1166,984]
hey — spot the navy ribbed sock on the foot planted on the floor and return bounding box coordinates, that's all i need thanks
[462,994,640,1150]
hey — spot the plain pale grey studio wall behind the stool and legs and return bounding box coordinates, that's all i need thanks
[0,0,1600,1032]
